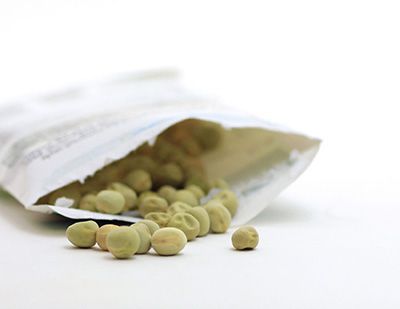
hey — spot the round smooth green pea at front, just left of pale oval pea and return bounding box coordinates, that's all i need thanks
[106,226,140,259]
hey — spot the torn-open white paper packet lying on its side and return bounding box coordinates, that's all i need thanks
[0,71,320,225]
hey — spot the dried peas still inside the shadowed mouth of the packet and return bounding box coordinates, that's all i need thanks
[36,119,231,215]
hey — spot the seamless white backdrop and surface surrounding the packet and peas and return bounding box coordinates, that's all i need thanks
[0,0,400,308]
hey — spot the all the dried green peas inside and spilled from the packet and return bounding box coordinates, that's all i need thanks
[58,119,258,259]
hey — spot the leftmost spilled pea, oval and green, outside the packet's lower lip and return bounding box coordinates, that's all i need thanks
[66,221,99,248]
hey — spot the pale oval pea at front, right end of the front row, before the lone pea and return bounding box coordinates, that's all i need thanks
[151,227,187,255]
